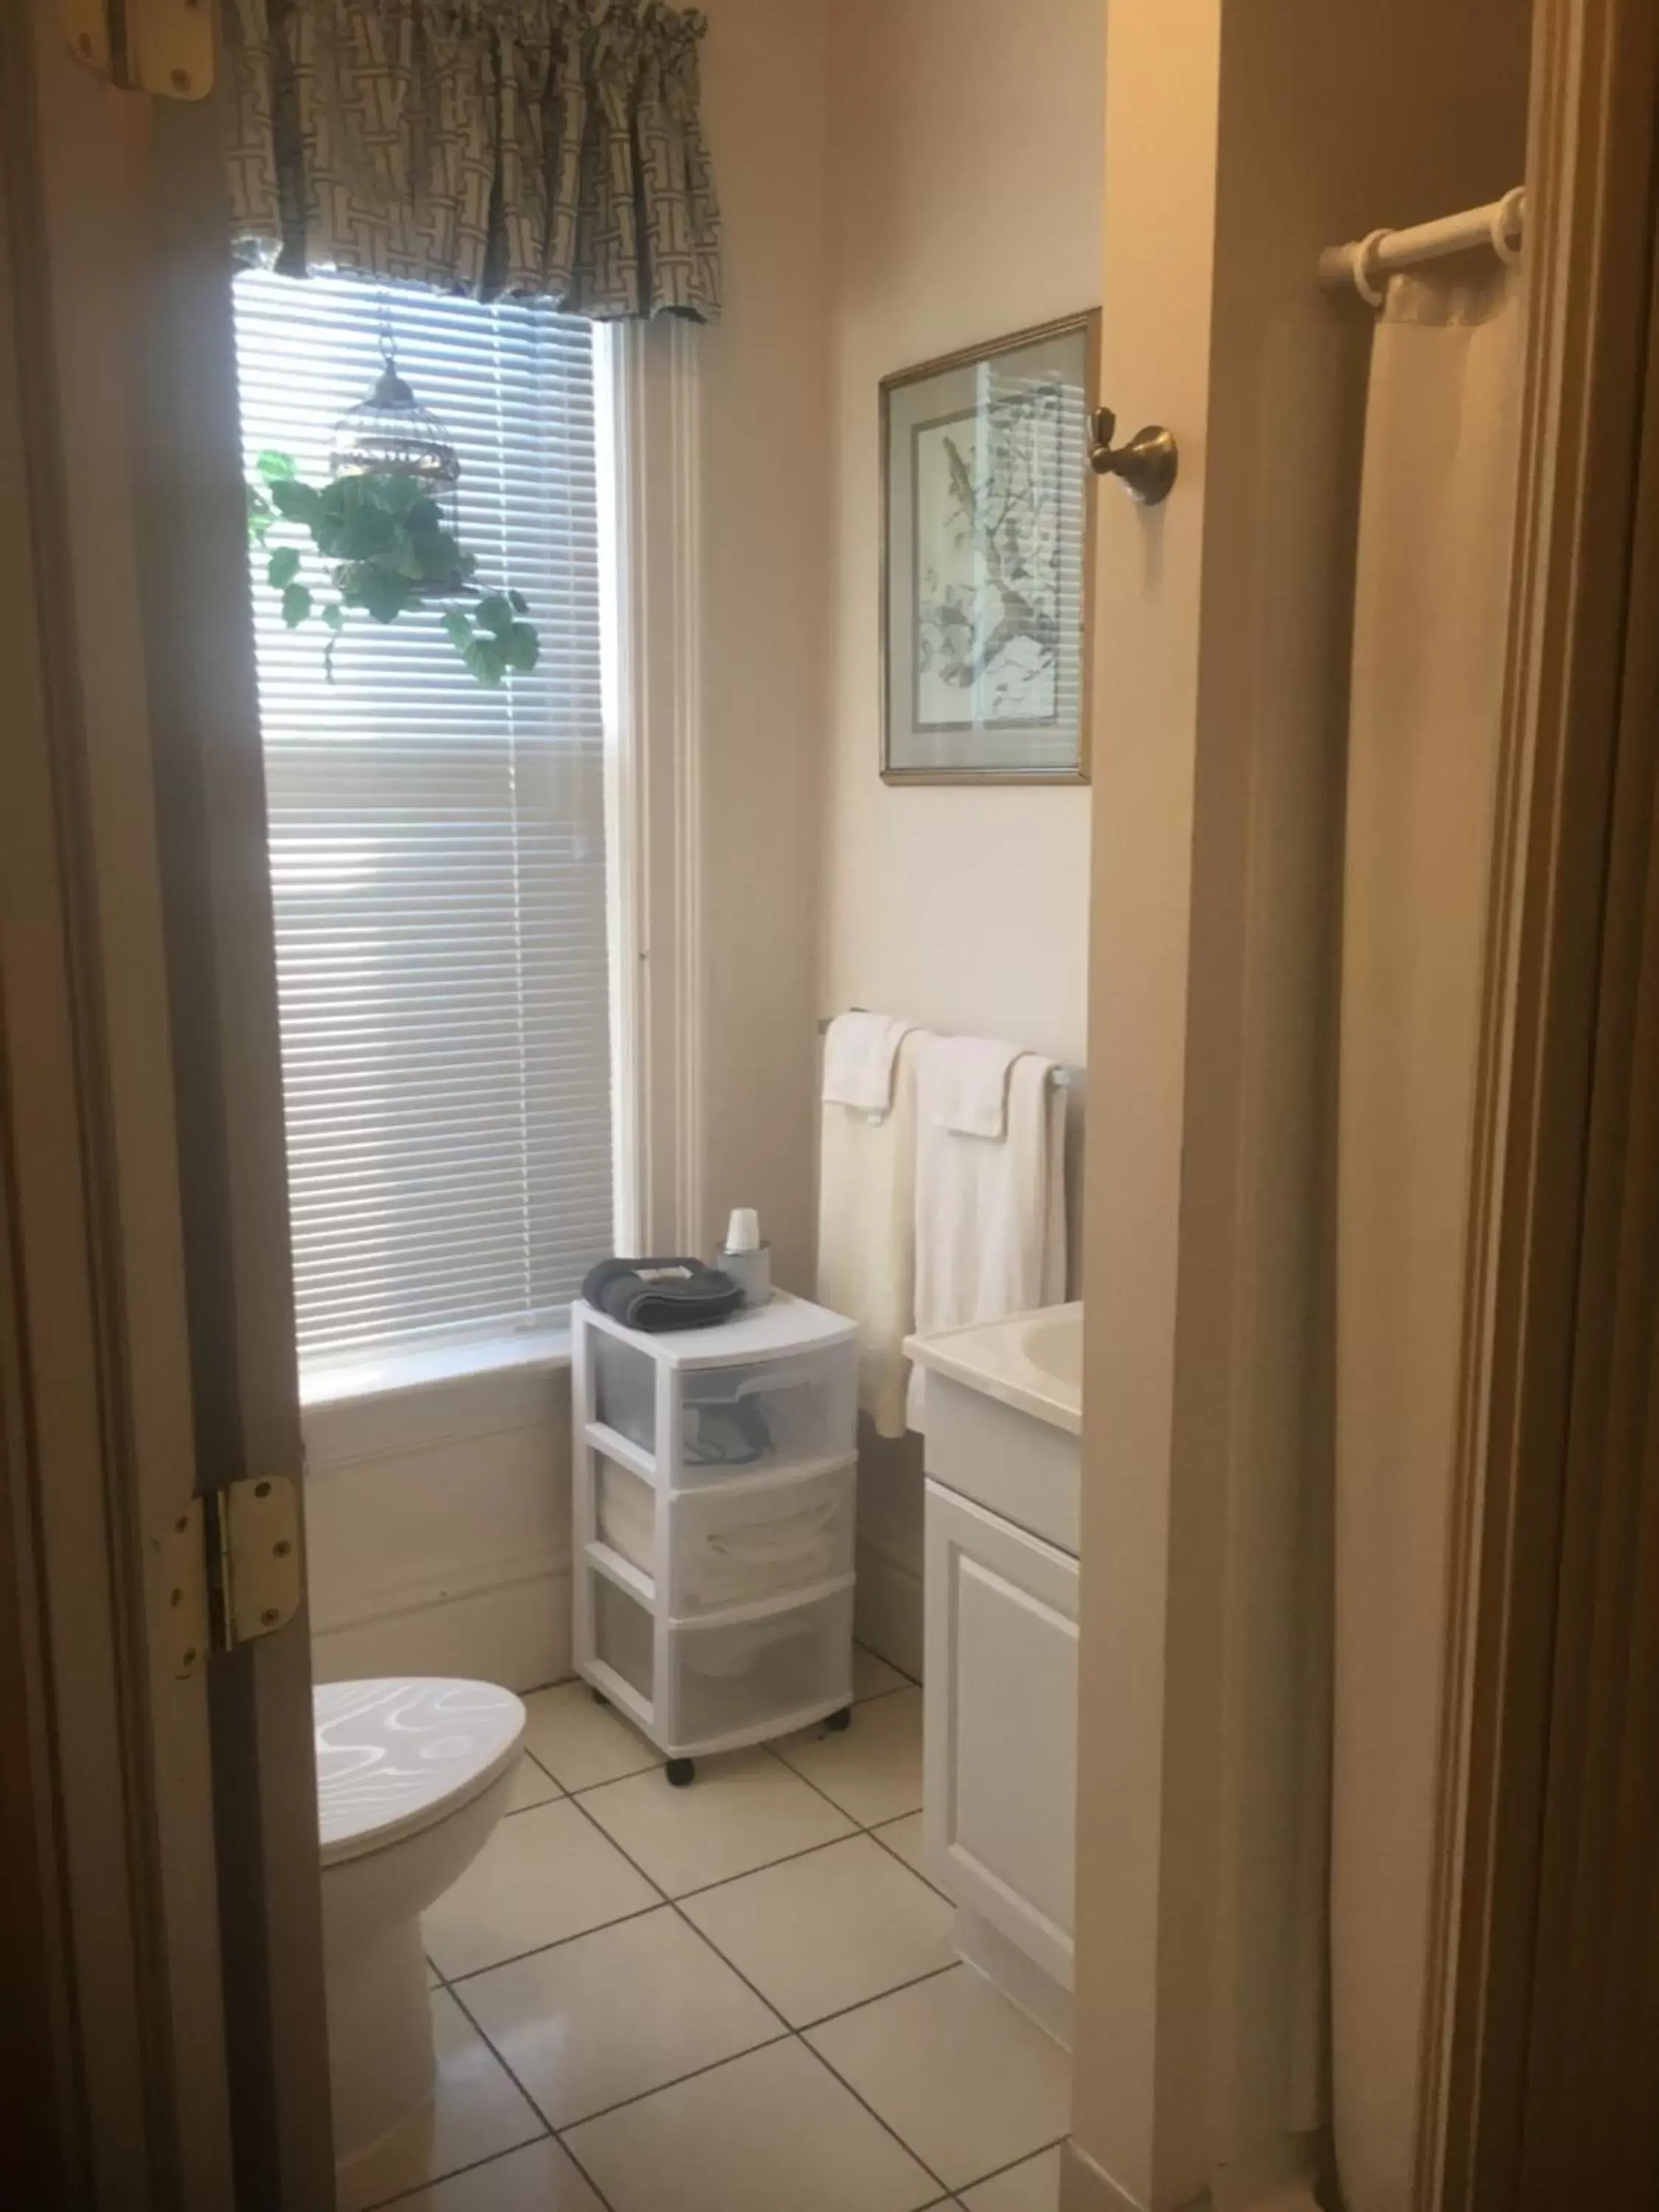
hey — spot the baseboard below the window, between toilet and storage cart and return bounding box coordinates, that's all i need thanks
[312,1564,571,1690]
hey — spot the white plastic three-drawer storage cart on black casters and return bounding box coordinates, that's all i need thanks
[573,1294,858,1785]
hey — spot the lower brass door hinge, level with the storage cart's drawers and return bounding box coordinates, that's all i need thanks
[153,1475,301,1679]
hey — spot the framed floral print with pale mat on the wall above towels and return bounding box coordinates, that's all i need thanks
[880,307,1099,783]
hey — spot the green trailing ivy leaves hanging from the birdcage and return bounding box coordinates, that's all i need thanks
[248,453,540,686]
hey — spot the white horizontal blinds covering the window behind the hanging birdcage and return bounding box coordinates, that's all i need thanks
[234,274,613,1374]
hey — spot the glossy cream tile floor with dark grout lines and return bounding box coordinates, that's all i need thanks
[343,1652,1068,2212]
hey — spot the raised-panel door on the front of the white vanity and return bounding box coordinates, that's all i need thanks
[925,1482,1077,1989]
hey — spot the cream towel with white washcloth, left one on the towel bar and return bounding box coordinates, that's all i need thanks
[818,1013,933,1436]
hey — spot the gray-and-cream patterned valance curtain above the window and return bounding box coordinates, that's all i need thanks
[223,0,719,323]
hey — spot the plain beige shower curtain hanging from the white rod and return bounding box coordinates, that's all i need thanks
[1332,268,1522,2212]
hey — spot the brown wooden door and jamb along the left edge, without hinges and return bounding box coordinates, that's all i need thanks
[0,0,332,2212]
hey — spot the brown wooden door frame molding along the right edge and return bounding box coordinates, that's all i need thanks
[1416,0,1659,2212]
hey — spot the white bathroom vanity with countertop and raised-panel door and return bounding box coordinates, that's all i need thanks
[911,1310,1079,2042]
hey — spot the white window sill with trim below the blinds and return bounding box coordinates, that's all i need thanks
[301,1329,571,1473]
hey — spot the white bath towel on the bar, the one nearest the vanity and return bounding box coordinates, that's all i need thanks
[909,1037,1066,1429]
